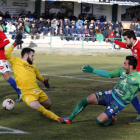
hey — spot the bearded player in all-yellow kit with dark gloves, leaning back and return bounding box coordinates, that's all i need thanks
[5,34,59,121]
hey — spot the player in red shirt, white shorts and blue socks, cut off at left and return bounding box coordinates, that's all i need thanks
[0,31,21,101]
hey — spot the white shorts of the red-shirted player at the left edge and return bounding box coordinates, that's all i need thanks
[0,60,11,73]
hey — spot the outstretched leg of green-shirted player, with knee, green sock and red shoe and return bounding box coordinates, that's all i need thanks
[58,94,98,123]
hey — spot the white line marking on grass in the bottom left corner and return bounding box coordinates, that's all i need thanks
[0,126,29,134]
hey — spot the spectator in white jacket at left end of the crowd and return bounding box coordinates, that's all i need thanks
[6,21,16,39]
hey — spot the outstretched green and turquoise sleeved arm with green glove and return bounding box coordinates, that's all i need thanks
[82,65,120,78]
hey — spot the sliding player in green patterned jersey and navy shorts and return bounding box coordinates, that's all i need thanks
[58,56,140,125]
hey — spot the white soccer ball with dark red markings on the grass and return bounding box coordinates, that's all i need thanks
[2,99,15,110]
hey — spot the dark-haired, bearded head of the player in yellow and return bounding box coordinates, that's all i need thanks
[21,48,35,64]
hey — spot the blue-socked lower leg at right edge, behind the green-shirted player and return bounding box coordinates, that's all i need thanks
[132,96,140,122]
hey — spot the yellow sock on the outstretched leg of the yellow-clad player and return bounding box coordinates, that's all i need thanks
[37,105,59,121]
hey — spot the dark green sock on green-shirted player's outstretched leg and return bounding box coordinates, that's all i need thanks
[69,98,88,121]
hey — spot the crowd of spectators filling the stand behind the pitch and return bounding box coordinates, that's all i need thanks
[0,11,140,42]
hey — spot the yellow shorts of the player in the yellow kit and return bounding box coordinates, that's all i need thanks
[21,88,48,106]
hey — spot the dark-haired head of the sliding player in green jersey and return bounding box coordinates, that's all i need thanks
[123,56,137,74]
